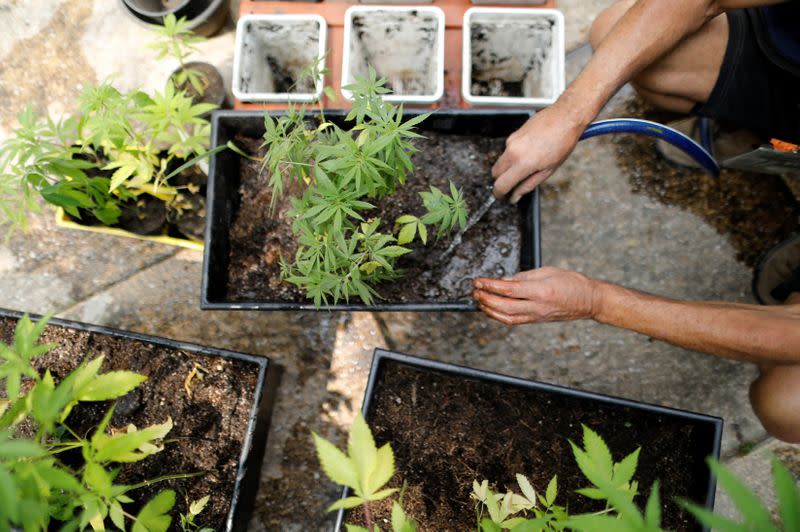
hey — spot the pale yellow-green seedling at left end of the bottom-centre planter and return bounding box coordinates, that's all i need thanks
[312,413,416,532]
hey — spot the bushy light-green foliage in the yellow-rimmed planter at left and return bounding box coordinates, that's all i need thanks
[0,78,219,232]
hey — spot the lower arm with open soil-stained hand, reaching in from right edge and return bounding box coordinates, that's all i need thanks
[474,268,800,364]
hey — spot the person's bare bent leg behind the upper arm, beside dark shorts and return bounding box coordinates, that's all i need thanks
[589,0,728,113]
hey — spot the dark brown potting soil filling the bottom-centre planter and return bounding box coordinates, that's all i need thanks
[345,360,705,532]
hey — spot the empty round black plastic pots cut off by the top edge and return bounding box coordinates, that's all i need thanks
[120,0,228,37]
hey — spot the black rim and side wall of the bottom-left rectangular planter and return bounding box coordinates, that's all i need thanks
[0,308,280,532]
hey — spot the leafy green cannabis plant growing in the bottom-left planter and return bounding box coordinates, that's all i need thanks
[0,315,191,532]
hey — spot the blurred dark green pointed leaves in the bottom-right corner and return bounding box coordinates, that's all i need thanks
[680,458,800,532]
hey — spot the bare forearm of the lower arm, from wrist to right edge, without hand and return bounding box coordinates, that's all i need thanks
[595,281,800,364]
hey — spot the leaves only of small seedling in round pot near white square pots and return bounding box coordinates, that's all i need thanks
[147,13,207,96]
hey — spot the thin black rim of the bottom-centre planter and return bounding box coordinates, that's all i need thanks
[334,348,723,532]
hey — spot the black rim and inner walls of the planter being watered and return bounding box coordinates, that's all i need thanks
[200,109,542,312]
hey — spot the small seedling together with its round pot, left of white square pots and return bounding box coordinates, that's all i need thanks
[148,13,225,107]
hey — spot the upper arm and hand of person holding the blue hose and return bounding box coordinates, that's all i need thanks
[492,0,785,203]
